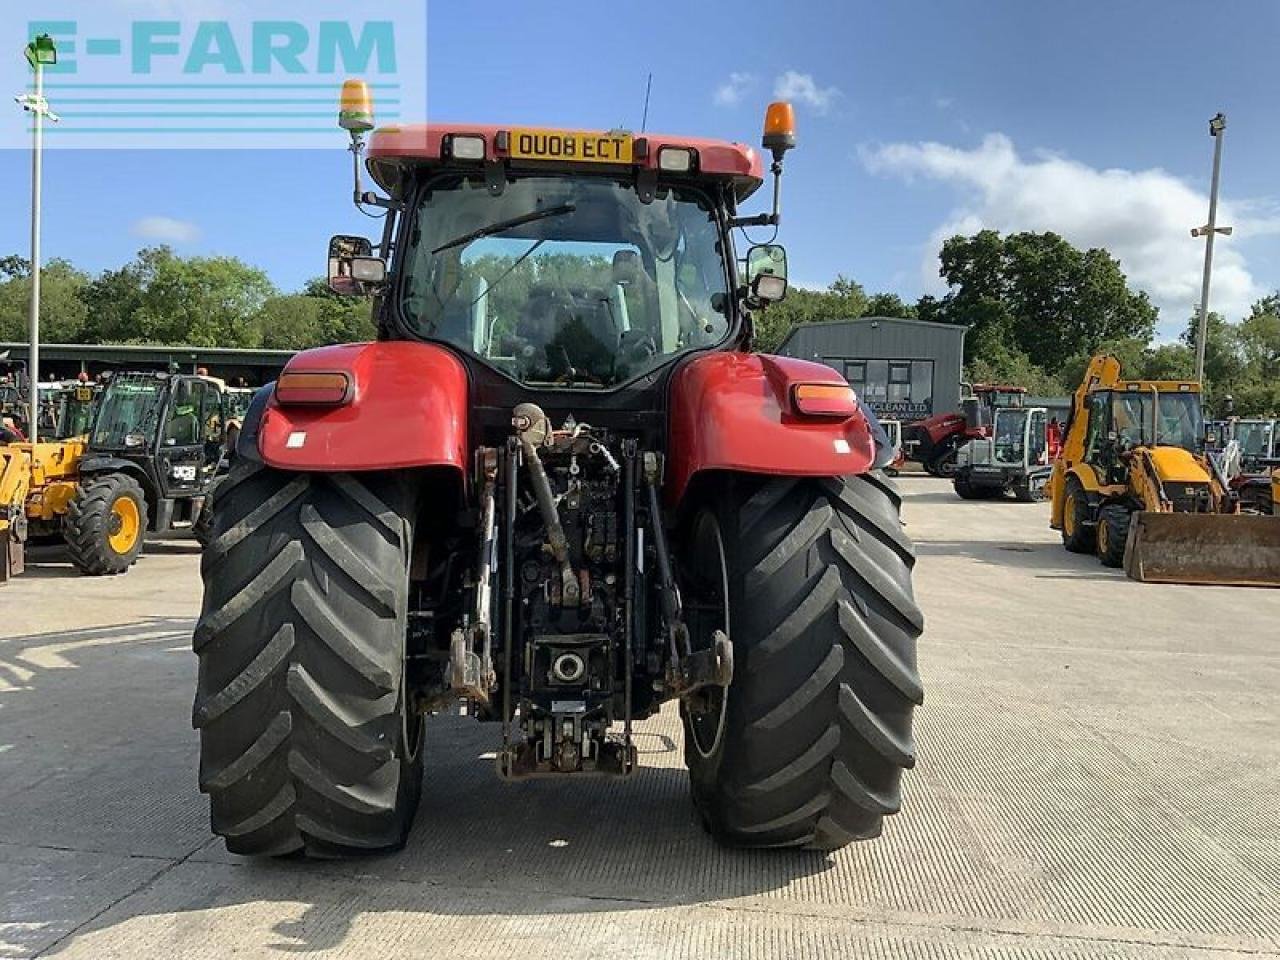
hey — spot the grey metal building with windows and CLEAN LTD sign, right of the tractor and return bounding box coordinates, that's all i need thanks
[778,316,968,421]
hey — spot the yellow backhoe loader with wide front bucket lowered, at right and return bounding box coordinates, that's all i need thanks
[1050,356,1280,586]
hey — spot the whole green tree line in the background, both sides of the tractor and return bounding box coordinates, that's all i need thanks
[0,230,1280,416]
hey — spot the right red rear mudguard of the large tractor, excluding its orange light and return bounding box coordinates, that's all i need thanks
[667,353,876,503]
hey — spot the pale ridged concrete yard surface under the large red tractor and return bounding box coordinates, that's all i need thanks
[0,476,1280,960]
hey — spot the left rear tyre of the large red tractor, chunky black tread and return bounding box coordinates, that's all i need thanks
[192,460,422,858]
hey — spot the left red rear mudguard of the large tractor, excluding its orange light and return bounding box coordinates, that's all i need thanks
[259,342,468,474]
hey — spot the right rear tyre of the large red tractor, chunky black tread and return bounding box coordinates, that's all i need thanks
[685,474,924,850]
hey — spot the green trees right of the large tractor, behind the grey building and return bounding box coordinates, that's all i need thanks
[756,230,1280,416]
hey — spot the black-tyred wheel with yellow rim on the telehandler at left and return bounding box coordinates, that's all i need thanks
[64,474,147,576]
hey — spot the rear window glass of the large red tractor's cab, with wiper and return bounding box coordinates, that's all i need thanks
[401,177,728,388]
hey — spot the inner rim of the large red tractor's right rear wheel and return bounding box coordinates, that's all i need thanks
[685,511,731,759]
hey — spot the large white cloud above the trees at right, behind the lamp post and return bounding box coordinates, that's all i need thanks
[860,133,1280,335]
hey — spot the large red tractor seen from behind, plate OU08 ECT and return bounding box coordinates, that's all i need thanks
[193,82,923,856]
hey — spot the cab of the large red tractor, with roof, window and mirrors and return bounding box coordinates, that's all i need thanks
[329,108,791,431]
